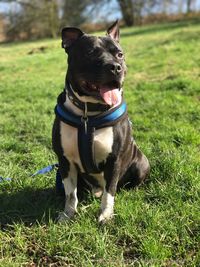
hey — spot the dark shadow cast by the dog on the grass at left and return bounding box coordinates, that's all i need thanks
[0,187,64,228]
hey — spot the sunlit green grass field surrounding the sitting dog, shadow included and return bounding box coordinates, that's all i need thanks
[0,21,200,267]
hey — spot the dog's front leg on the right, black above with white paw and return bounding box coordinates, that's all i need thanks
[98,160,120,223]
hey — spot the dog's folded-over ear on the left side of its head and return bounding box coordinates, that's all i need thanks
[62,27,84,52]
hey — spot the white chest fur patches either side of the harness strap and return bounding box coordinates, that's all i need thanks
[60,121,113,172]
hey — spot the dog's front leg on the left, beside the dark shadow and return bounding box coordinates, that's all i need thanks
[58,163,78,222]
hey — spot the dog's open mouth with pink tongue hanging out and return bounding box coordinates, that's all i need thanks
[81,80,122,106]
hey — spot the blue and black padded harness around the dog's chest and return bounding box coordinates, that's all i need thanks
[55,102,127,174]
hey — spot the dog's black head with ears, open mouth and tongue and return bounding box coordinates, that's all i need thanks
[62,21,126,106]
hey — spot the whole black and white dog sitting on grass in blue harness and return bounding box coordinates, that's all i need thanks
[53,22,149,222]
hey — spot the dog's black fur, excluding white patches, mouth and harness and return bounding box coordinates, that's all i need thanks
[52,20,150,222]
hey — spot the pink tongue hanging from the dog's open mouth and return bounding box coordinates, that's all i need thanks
[100,87,122,106]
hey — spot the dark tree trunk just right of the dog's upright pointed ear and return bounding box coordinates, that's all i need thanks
[118,0,134,26]
